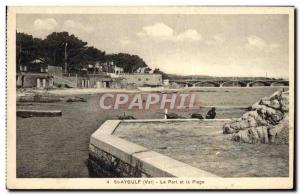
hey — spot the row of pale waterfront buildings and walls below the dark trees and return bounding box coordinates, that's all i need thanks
[17,60,162,88]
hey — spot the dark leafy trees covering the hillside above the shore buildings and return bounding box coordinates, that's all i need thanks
[16,32,148,73]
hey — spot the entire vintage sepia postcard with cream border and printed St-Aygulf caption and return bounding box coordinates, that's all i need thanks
[7,6,295,190]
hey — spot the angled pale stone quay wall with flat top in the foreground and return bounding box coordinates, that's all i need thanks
[88,119,217,178]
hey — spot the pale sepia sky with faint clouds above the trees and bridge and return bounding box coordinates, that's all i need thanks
[17,14,289,78]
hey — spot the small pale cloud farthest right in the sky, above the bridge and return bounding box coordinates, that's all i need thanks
[245,35,280,52]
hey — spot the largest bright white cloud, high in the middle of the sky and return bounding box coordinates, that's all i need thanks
[137,22,202,42]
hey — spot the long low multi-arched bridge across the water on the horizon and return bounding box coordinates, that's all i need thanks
[169,79,289,87]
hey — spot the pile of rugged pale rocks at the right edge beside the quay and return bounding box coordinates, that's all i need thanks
[223,90,289,144]
